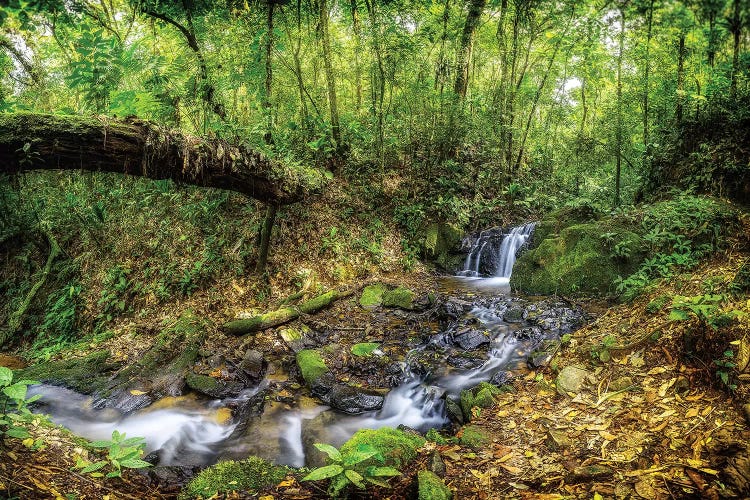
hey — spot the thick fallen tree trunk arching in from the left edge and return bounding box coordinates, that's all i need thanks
[0,113,311,205]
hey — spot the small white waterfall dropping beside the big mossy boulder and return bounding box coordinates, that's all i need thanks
[458,222,536,279]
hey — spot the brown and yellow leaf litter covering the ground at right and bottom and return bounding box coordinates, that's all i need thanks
[0,242,750,499]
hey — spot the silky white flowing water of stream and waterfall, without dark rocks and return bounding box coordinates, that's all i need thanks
[30,224,533,467]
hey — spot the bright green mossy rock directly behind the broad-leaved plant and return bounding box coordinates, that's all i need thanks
[340,427,425,469]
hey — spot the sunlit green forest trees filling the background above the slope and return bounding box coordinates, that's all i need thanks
[0,0,750,213]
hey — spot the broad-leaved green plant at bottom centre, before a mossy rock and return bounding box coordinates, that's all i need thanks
[302,443,401,498]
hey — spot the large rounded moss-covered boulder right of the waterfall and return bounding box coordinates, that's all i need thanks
[510,223,645,295]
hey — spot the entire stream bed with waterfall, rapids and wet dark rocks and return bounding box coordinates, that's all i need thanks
[29,224,583,467]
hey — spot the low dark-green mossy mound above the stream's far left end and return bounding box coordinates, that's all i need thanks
[14,350,120,395]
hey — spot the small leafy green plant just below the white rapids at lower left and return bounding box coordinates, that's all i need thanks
[74,430,151,478]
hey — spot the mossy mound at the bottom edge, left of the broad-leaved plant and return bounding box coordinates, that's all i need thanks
[179,457,294,500]
